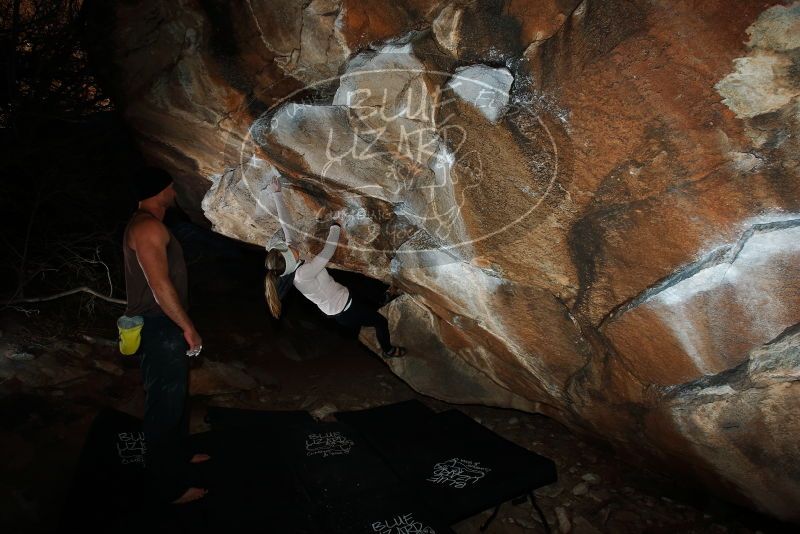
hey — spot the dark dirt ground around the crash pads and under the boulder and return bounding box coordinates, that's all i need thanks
[0,254,790,534]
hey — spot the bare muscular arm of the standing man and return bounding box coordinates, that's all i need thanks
[130,218,202,349]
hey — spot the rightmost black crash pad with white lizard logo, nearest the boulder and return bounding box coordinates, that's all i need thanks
[337,410,557,524]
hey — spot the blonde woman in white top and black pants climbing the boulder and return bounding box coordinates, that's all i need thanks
[264,177,406,358]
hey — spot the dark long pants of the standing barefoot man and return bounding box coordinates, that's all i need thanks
[139,314,190,502]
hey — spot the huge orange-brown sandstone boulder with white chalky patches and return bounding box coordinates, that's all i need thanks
[90,0,800,521]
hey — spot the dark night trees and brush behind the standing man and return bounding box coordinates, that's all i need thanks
[0,0,135,313]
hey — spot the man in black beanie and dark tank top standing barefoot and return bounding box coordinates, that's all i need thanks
[123,168,209,504]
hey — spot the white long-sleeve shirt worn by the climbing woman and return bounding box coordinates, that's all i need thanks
[273,192,350,315]
